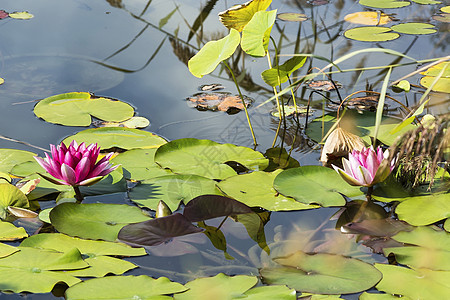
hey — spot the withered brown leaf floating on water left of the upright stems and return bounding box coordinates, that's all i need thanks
[187,92,253,114]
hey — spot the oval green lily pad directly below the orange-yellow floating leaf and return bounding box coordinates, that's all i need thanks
[344,26,398,42]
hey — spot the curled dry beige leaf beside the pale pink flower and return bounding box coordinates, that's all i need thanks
[320,127,364,165]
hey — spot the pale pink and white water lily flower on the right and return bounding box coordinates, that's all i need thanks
[333,146,394,187]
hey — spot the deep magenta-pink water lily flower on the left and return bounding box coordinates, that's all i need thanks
[34,141,119,187]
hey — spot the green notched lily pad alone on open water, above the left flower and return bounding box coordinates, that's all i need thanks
[34,92,134,126]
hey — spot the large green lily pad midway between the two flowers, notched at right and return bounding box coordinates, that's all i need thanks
[155,138,269,179]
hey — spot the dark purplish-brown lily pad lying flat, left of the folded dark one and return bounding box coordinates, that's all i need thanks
[119,213,203,247]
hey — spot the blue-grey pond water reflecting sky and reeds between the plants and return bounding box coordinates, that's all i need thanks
[0,0,450,299]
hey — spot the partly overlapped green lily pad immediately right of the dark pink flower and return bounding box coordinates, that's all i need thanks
[111,149,170,180]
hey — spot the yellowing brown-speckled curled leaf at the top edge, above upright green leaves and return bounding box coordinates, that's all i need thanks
[219,0,272,32]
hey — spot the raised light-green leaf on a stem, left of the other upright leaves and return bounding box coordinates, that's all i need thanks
[188,28,241,78]
